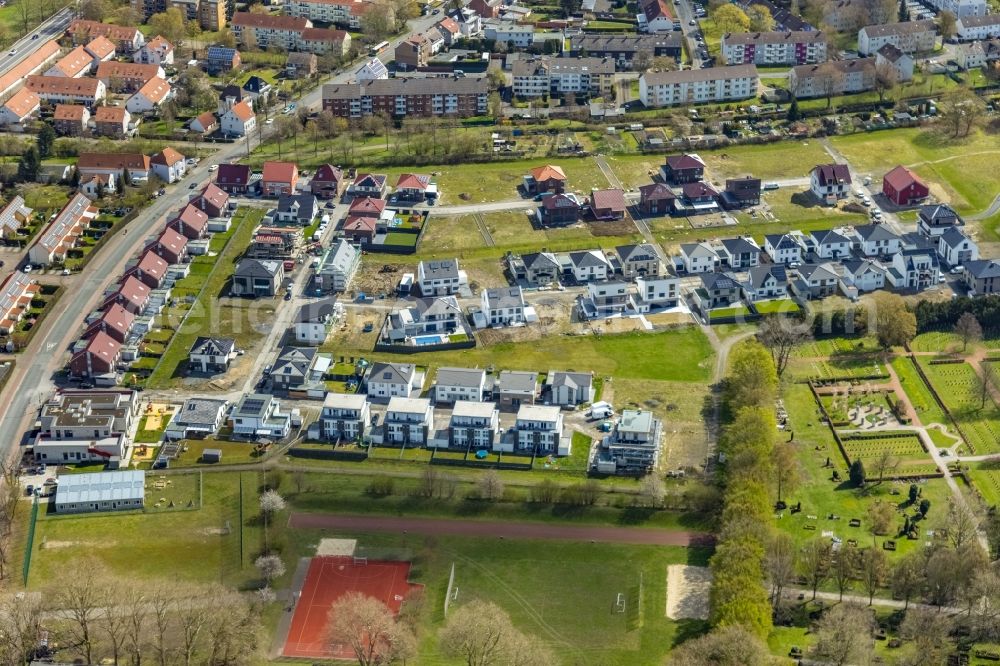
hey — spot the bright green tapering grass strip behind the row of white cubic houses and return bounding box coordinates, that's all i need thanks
[323,326,713,382]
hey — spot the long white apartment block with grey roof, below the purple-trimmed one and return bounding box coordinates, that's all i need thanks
[639,65,760,108]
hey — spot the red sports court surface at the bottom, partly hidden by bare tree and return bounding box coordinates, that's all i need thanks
[282,557,420,659]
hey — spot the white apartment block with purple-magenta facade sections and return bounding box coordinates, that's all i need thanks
[722,30,826,65]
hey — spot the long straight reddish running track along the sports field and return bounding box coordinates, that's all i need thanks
[288,513,715,546]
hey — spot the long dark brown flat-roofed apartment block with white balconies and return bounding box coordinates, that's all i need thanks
[323,76,490,118]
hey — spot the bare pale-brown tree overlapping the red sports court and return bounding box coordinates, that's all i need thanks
[328,592,415,666]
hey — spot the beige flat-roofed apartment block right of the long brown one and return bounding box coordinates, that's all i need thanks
[512,57,615,97]
